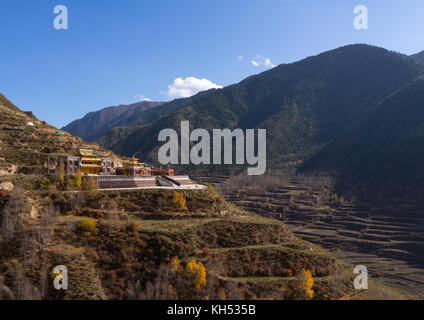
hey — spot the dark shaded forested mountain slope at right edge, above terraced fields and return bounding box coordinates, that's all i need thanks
[305,76,424,194]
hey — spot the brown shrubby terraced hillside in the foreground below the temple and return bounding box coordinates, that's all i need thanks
[0,190,366,299]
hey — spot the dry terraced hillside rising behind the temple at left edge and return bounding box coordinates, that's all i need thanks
[0,95,117,176]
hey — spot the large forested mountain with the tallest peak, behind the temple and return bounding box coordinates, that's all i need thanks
[105,45,423,174]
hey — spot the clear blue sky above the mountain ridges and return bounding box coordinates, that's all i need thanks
[0,0,424,127]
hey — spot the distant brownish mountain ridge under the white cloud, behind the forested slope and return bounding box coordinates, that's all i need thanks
[62,101,162,141]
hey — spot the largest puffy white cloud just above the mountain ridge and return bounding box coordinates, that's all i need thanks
[166,77,222,98]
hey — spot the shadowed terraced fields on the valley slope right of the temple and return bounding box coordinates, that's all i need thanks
[197,176,424,296]
